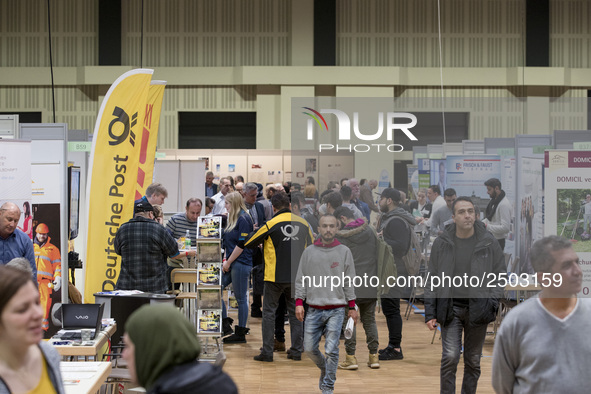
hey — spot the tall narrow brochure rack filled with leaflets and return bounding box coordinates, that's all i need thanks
[196,217,222,361]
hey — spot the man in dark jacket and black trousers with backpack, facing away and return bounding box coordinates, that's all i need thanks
[378,187,416,360]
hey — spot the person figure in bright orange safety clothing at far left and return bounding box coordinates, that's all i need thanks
[34,223,62,331]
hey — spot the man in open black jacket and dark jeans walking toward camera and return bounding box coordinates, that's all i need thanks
[425,197,507,393]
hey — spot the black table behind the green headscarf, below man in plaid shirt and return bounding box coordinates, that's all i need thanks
[94,292,176,345]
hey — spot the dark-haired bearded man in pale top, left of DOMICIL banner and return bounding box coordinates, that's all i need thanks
[482,178,513,250]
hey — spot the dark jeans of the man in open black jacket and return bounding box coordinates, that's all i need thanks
[440,306,487,393]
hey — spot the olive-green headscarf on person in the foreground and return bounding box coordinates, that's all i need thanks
[125,304,201,391]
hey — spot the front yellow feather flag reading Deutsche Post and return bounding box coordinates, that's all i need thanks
[84,69,154,302]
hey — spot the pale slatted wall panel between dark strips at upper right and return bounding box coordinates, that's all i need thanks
[337,0,525,67]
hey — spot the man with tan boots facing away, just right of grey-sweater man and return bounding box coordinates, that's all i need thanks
[334,208,380,370]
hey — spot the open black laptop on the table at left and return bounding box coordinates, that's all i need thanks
[61,303,105,340]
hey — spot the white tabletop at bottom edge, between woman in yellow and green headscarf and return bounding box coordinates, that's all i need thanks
[60,361,111,394]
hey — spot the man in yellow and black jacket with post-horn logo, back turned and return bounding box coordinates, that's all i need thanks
[244,193,313,362]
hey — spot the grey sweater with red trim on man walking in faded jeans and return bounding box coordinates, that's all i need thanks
[295,240,355,307]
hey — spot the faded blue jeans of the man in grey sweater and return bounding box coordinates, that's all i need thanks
[304,308,345,390]
